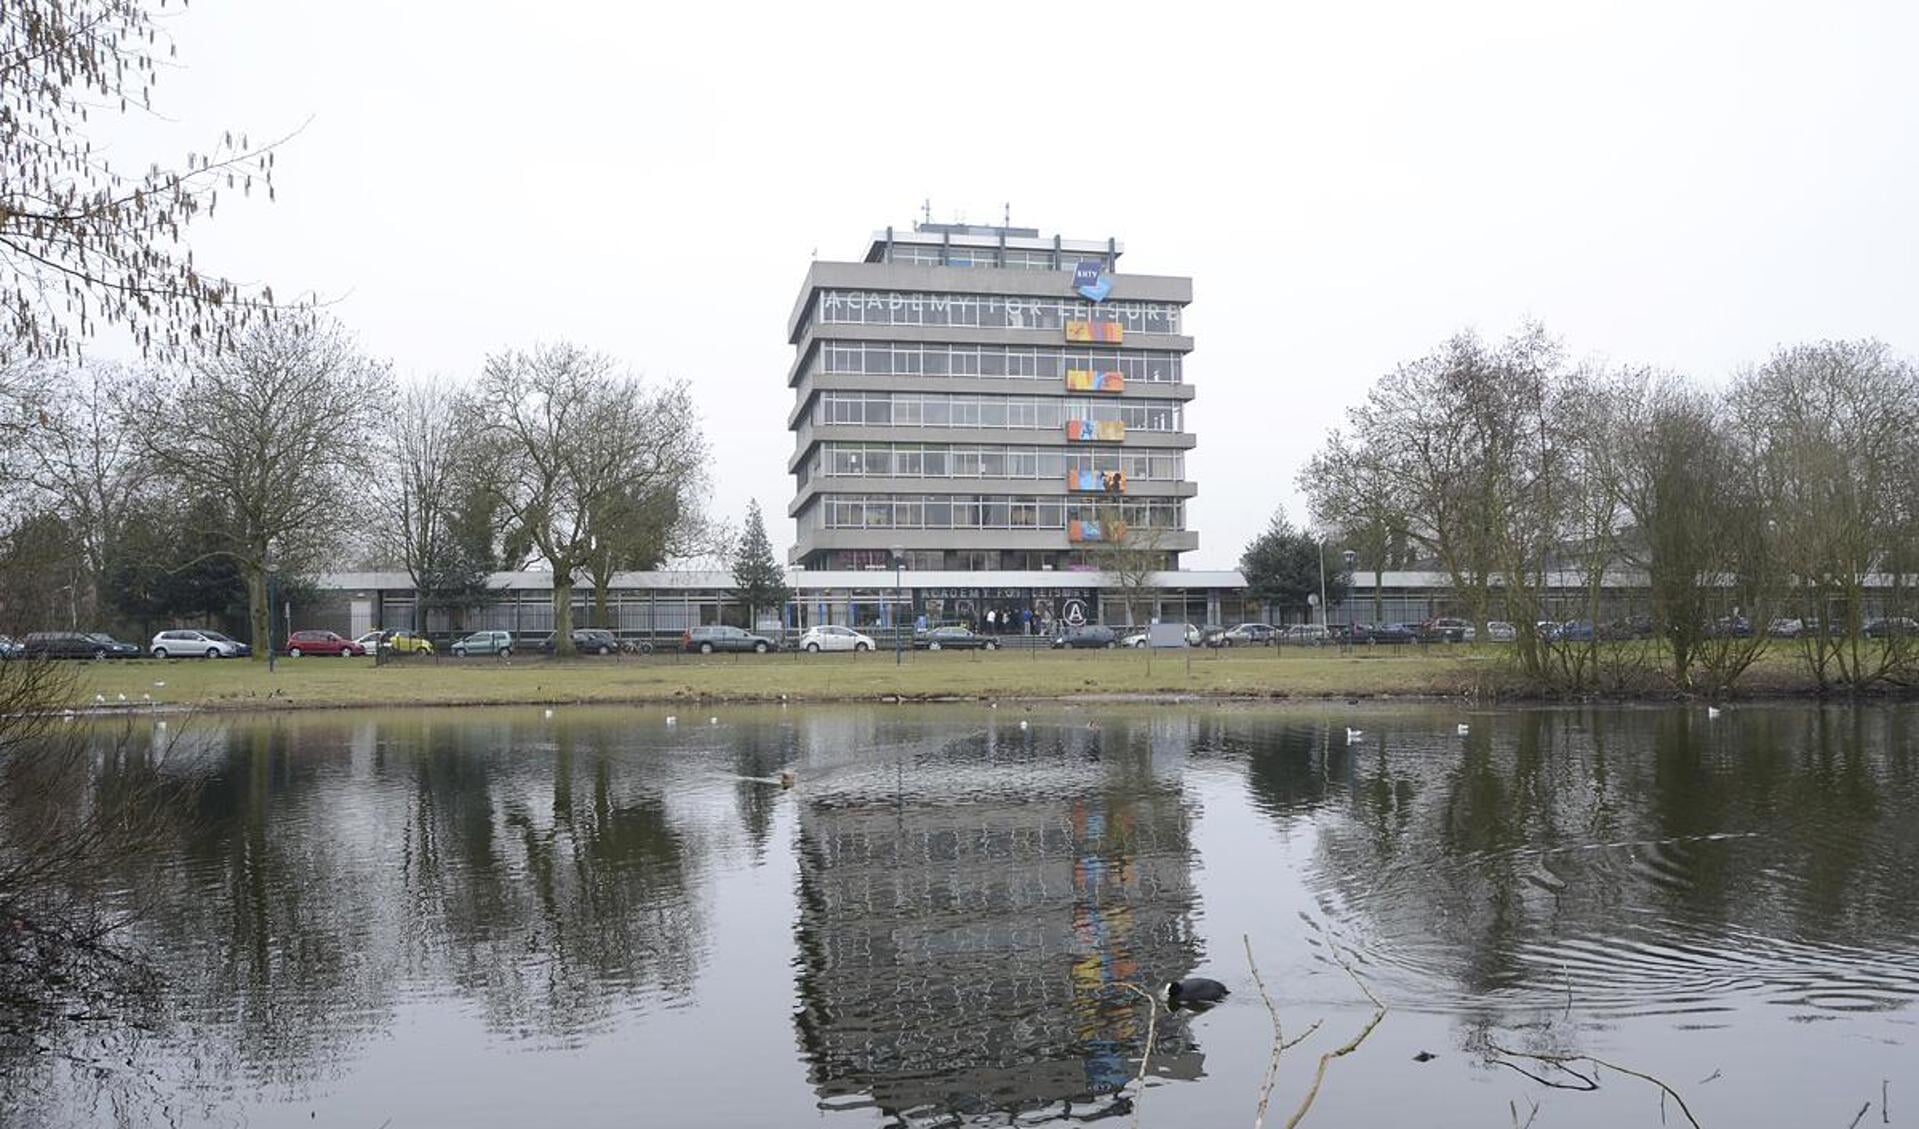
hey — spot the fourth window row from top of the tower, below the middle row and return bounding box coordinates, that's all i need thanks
[810,444,1186,482]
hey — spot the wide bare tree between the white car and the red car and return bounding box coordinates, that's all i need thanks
[134,321,391,659]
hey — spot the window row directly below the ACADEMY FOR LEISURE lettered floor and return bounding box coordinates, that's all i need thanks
[812,342,1184,384]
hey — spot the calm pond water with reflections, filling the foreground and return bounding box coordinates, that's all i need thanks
[0,705,1919,1129]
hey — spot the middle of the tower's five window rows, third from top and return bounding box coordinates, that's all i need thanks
[814,392,1184,432]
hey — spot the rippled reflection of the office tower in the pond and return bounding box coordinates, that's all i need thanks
[796,725,1199,1121]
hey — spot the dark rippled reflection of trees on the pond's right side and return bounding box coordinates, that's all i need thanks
[1249,707,1919,1025]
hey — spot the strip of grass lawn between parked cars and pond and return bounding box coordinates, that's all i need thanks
[75,647,1493,709]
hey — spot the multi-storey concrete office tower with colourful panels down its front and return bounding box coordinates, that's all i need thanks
[787,223,1197,572]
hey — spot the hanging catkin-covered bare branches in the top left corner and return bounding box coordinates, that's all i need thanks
[0,0,293,357]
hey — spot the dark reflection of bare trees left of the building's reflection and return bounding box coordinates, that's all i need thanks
[18,718,704,1121]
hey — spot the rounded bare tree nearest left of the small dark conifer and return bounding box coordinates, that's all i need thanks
[472,344,704,655]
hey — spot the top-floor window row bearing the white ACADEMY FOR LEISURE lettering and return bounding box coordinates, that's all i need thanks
[808,290,1180,334]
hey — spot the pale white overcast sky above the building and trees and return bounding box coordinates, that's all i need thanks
[97,0,1919,566]
